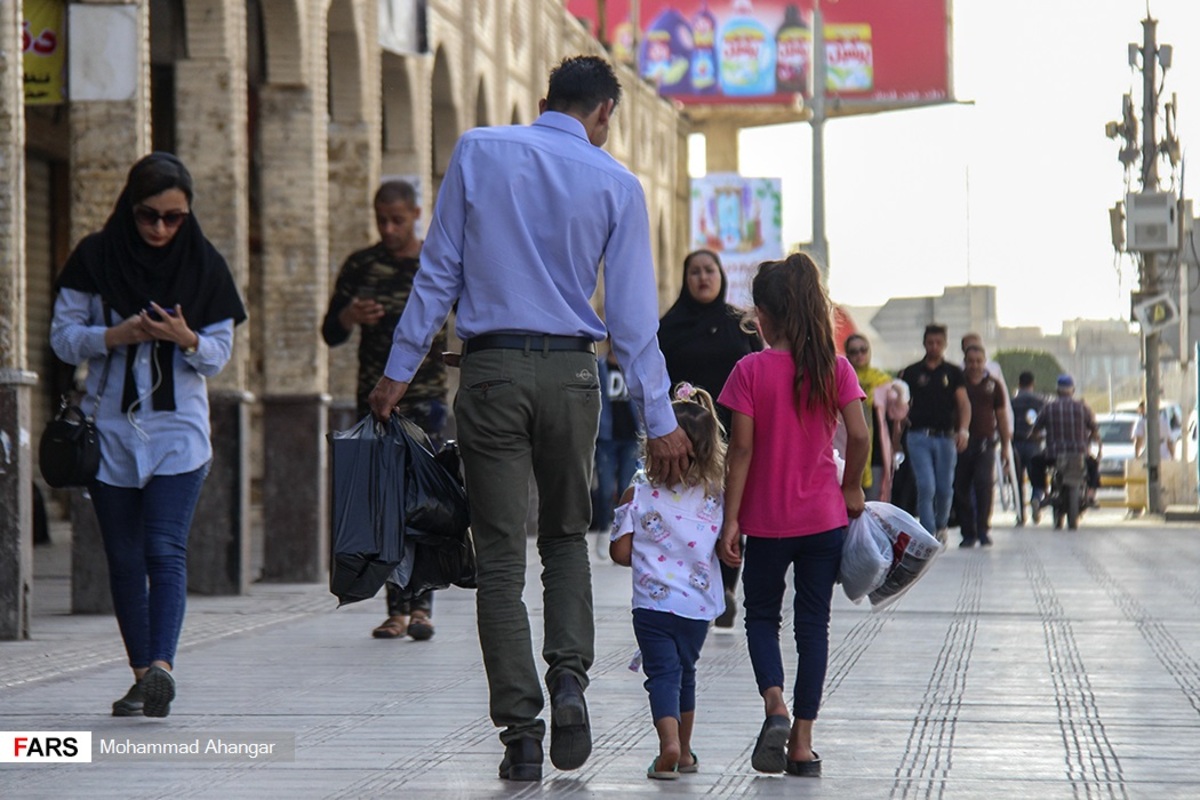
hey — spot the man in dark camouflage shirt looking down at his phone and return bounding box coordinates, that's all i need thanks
[320,181,446,642]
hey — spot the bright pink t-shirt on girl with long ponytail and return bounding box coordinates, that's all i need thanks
[719,350,865,539]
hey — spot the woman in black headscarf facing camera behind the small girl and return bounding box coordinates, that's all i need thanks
[659,249,762,628]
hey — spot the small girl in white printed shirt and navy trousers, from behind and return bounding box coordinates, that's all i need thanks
[608,384,725,780]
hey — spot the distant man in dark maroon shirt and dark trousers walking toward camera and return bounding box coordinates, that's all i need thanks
[954,344,1012,547]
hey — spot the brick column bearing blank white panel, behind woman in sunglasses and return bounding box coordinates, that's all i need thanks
[68,2,150,613]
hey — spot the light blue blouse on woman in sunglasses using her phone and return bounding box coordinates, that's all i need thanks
[50,289,234,488]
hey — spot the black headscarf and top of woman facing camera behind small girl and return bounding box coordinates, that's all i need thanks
[659,251,762,431]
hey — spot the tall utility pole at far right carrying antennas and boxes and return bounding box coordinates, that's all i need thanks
[1141,16,1163,513]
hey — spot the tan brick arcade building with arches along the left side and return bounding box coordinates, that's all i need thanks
[0,0,689,638]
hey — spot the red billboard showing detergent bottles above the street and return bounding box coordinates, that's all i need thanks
[566,0,953,107]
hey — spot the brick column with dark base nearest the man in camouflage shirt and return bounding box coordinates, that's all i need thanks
[259,77,330,582]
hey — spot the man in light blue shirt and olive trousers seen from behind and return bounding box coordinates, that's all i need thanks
[370,56,691,781]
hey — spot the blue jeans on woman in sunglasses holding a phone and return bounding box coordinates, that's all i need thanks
[89,463,211,669]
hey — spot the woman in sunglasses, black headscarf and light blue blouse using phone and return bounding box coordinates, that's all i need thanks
[50,152,246,717]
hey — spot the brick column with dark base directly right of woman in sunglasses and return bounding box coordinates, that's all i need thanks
[175,0,254,595]
